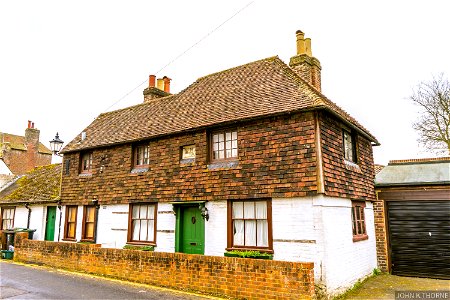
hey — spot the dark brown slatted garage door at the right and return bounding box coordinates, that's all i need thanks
[387,201,450,279]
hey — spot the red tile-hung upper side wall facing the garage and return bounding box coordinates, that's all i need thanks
[320,113,375,200]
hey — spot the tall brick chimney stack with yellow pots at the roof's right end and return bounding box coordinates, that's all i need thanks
[289,30,322,92]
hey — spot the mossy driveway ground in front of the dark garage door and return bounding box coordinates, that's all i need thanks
[340,274,450,300]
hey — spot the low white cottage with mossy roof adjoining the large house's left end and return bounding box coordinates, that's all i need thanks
[0,164,61,241]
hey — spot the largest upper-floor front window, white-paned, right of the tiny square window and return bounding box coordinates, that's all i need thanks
[211,130,238,161]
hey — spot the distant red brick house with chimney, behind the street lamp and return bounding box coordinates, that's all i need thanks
[0,121,52,176]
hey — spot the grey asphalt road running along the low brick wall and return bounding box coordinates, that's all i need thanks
[0,260,219,300]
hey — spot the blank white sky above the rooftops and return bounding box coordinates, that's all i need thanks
[0,0,450,165]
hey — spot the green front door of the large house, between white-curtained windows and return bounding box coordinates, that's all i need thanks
[179,206,205,254]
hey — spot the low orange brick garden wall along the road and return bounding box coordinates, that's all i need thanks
[14,234,314,299]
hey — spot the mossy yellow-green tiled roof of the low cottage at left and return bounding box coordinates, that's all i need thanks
[0,164,61,204]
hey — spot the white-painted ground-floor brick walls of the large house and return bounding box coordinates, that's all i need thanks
[61,195,377,295]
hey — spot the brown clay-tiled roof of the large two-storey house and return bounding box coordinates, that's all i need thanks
[62,57,378,153]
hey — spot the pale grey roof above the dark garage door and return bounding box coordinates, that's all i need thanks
[375,157,450,186]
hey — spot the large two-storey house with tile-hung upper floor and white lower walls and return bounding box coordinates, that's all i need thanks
[61,31,378,293]
